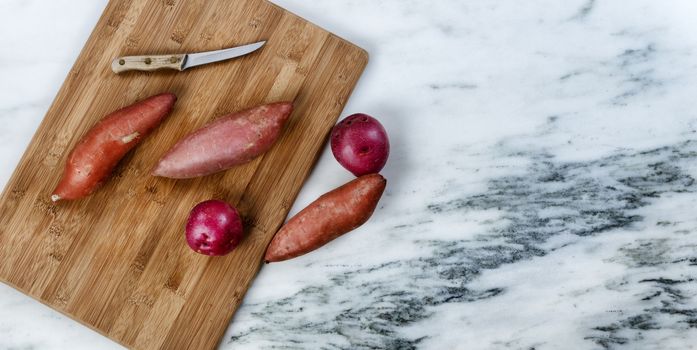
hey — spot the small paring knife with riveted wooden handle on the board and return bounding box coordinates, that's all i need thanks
[111,41,266,74]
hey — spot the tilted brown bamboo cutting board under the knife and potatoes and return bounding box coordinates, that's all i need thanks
[0,0,368,349]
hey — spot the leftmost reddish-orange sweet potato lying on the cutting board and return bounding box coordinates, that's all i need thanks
[51,93,177,202]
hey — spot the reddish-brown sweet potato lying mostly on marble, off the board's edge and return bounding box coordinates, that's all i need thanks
[264,174,387,263]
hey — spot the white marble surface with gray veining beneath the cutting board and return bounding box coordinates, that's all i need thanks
[0,0,697,349]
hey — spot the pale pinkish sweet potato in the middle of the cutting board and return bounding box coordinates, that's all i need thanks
[152,102,293,179]
